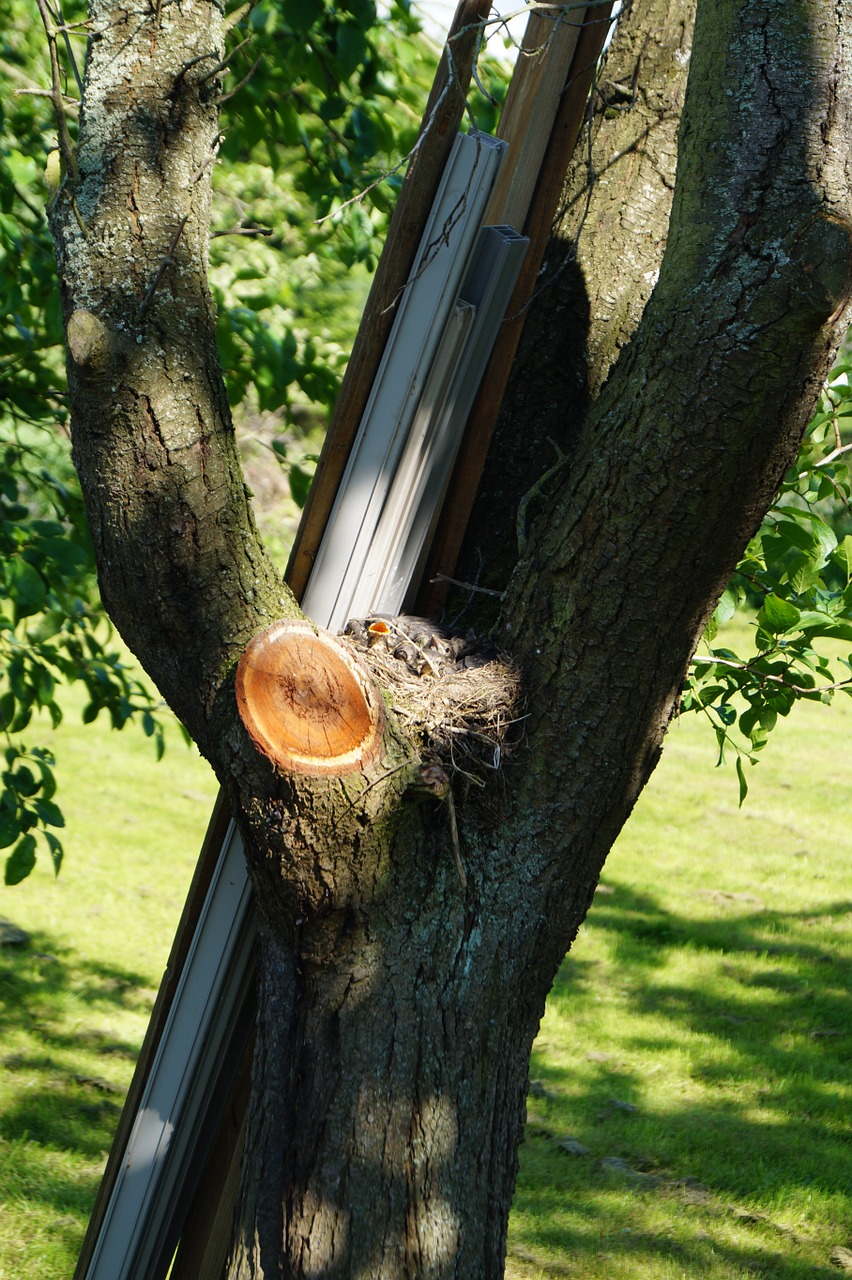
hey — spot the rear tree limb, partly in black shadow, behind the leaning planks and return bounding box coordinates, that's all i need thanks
[448,0,696,614]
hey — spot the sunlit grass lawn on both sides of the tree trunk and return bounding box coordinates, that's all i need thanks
[0,632,852,1280]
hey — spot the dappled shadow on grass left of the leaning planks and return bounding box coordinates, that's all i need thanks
[0,933,154,1223]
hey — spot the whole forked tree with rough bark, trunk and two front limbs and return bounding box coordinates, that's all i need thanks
[36,0,852,1277]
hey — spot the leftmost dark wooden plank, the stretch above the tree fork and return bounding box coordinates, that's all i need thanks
[287,0,490,599]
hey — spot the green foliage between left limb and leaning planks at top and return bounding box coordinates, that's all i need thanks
[211,0,436,432]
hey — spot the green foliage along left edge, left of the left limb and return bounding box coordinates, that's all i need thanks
[0,0,164,884]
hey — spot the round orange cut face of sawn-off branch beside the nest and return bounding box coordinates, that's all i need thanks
[230,621,384,776]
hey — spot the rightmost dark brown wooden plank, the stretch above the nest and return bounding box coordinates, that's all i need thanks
[413,4,613,617]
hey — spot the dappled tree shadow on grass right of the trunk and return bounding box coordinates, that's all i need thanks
[509,884,852,1280]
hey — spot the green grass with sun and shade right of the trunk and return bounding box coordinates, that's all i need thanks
[507,655,852,1280]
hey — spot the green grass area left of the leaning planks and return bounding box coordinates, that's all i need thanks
[0,713,216,1280]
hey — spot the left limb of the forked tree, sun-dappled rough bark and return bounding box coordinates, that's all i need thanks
[51,0,296,754]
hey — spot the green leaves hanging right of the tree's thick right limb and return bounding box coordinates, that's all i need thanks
[681,351,852,788]
